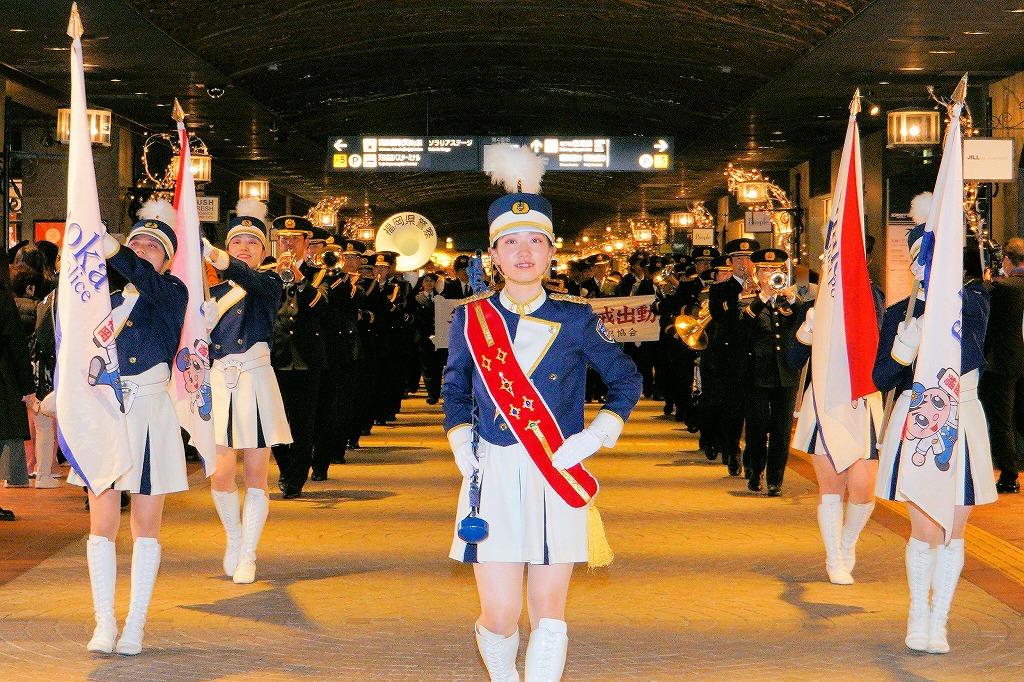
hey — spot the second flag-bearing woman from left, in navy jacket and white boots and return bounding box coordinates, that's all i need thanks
[204,200,292,584]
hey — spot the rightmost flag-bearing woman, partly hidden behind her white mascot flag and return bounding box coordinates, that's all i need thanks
[872,206,997,653]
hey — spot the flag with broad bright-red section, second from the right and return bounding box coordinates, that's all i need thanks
[811,91,882,471]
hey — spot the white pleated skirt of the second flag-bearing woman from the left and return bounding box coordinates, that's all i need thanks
[210,342,292,450]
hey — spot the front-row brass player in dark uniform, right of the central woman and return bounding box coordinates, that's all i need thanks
[740,249,807,497]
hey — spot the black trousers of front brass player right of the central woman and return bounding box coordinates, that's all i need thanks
[743,386,797,485]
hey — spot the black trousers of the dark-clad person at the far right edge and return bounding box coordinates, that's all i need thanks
[978,372,1024,483]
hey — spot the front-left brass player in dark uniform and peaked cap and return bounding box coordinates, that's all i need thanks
[270,215,328,500]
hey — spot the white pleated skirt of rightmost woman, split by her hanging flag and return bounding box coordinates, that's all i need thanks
[874,370,998,506]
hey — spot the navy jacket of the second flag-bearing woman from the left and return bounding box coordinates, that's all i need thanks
[210,257,284,359]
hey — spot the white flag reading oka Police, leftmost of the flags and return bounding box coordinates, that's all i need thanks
[53,3,131,493]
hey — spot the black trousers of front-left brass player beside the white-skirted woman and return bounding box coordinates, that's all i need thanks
[272,370,321,491]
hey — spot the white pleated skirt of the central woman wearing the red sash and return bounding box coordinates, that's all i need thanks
[449,440,588,564]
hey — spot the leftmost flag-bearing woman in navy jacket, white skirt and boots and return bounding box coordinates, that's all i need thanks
[68,202,188,655]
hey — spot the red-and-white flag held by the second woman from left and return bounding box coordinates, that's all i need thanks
[168,99,216,476]
